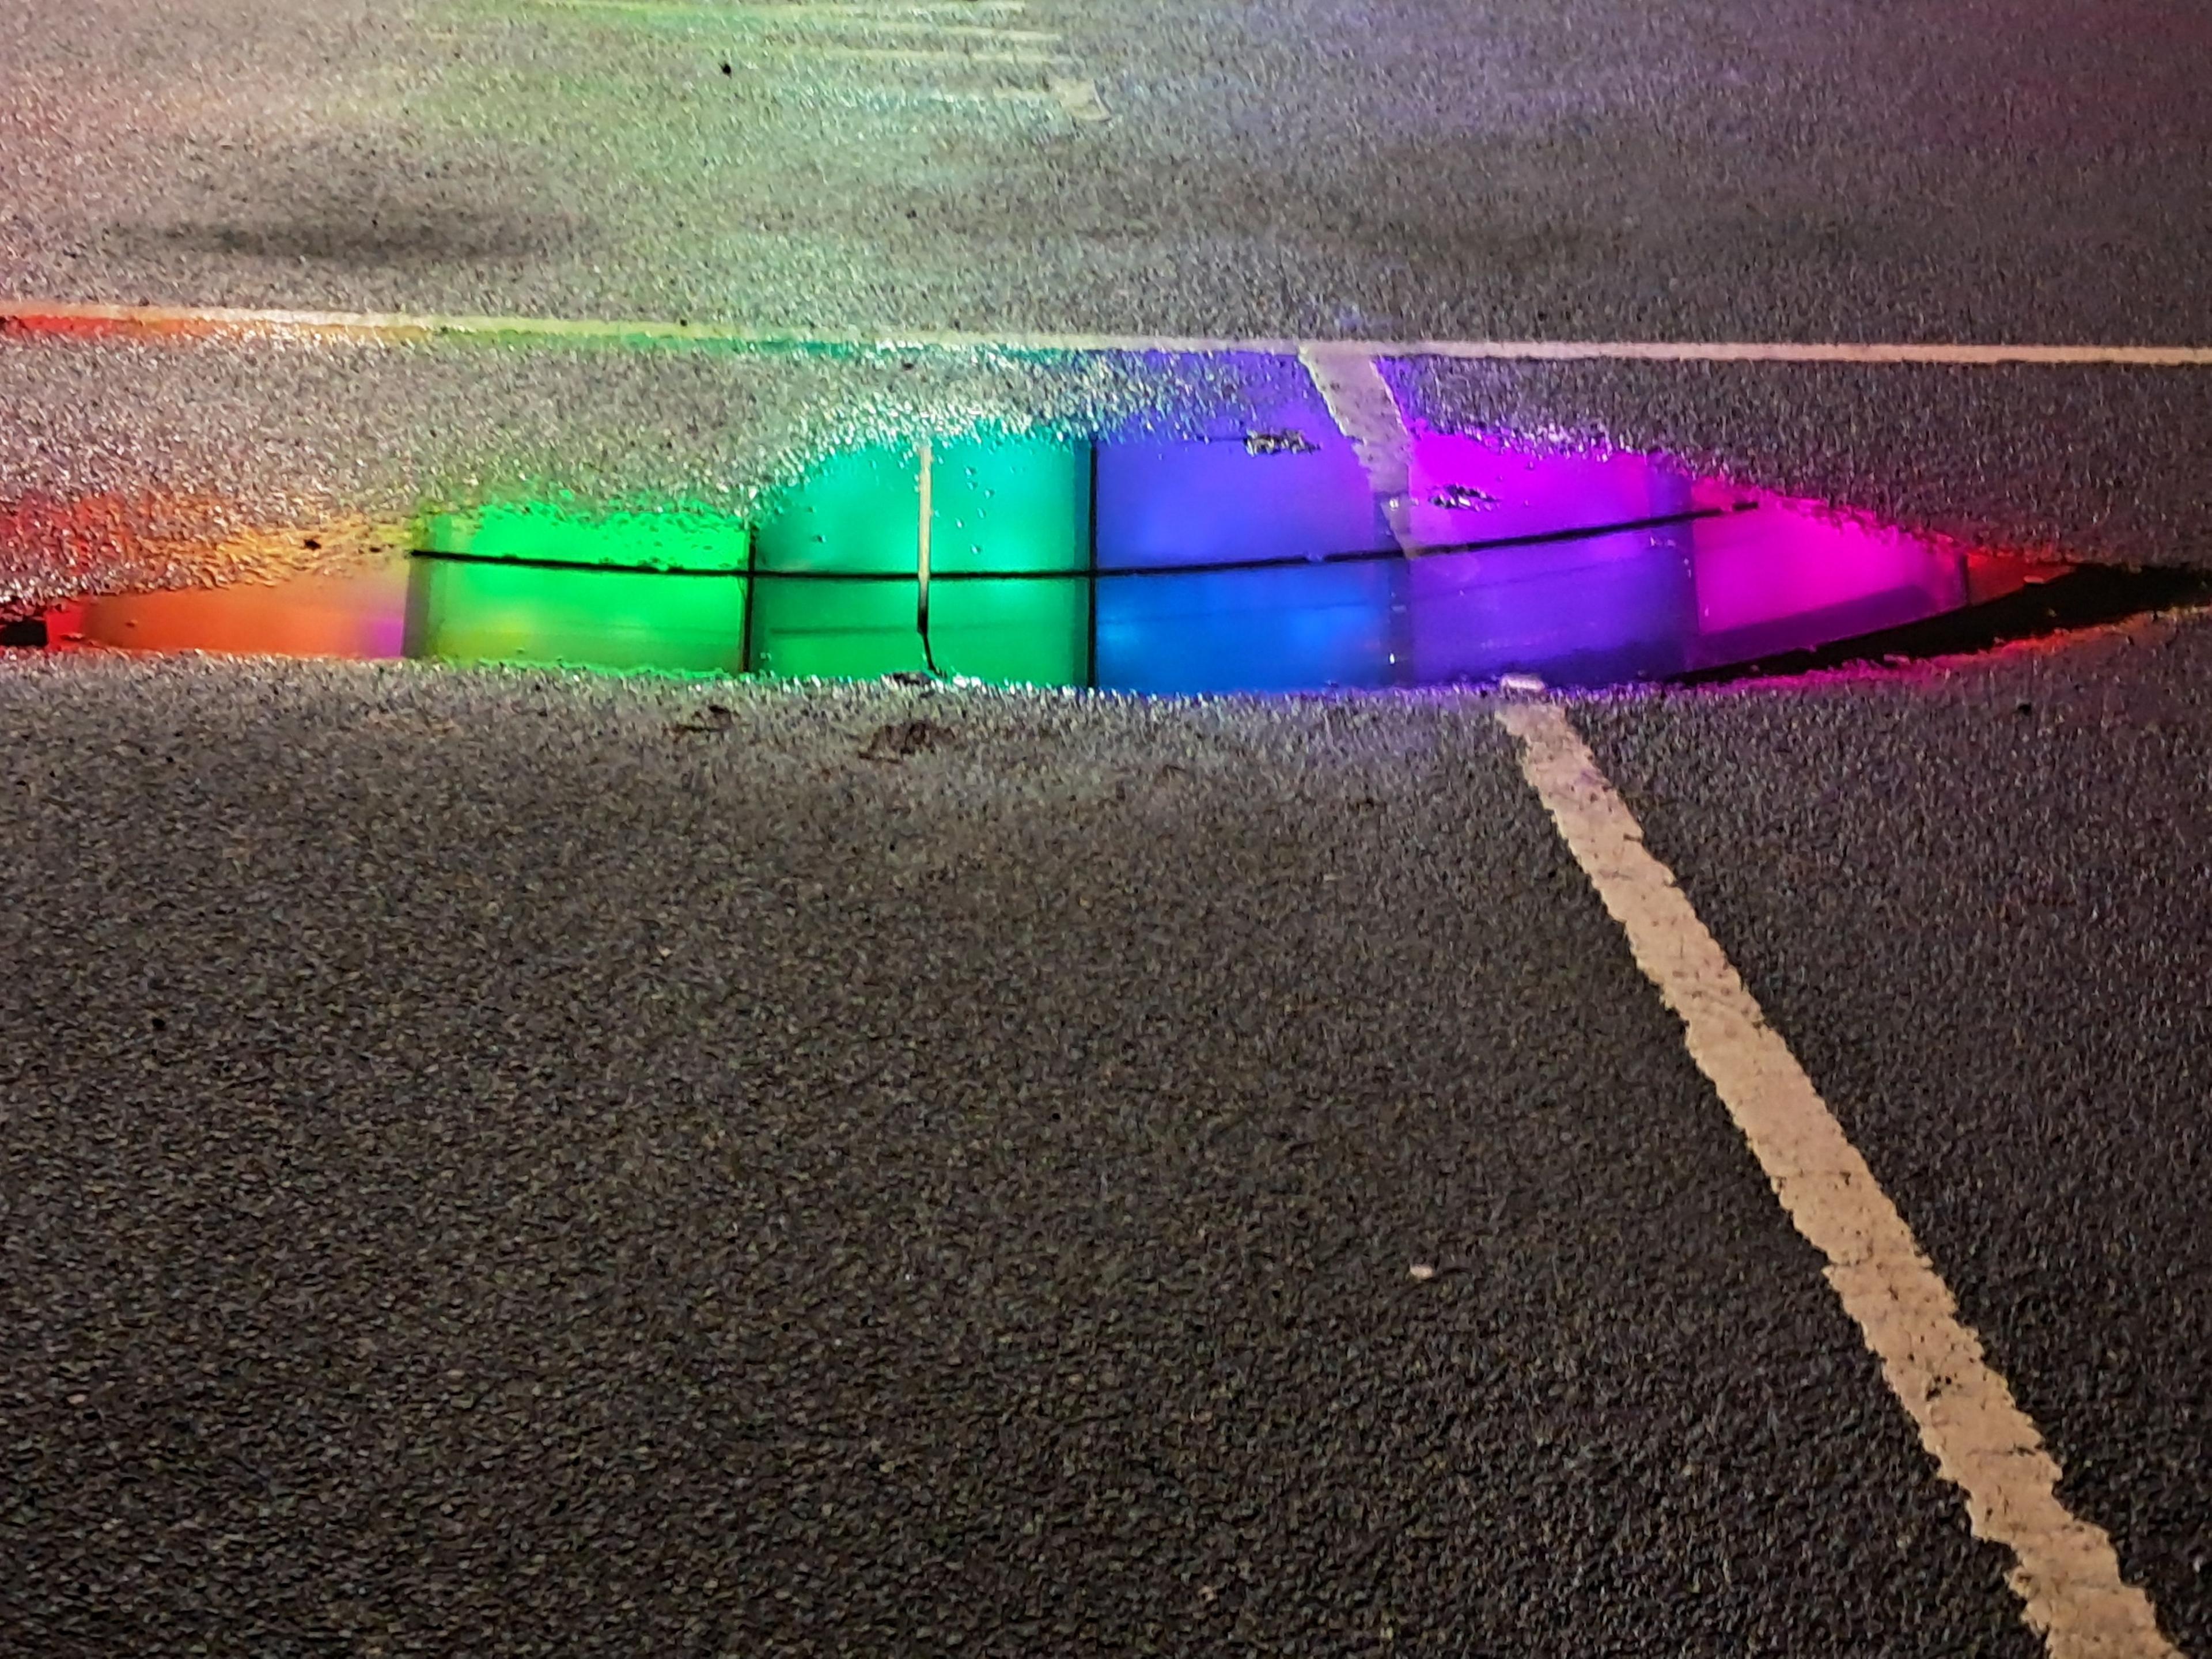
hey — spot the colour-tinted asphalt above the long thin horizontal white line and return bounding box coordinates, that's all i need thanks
[17,0,2212,343]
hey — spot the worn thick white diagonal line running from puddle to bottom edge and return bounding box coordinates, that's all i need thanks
[1498,703,2181,1659]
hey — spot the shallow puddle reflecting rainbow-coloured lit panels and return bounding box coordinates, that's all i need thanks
[17,422,2057,692]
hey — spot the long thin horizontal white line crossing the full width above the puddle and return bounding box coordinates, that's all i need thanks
[13,298,2212,369]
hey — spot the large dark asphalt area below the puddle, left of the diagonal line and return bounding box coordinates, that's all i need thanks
[0,657,2070,1654]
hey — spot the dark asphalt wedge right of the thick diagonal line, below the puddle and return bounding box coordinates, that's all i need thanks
[1577,622,2212,1652]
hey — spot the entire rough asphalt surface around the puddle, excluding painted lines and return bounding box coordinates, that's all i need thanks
[13,0,2212,1659]
